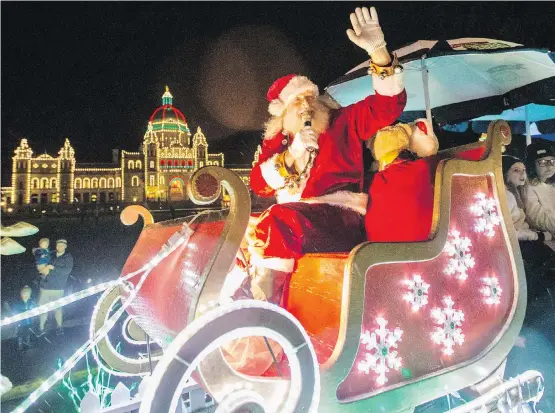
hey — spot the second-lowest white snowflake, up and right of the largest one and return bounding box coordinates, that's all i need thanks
[432,296,464,356]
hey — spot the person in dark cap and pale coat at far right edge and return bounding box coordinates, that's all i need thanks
[526,142,555,235]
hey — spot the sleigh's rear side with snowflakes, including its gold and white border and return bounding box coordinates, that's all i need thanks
[321,121,526,413]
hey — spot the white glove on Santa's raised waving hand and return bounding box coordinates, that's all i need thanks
[347,7,387,54]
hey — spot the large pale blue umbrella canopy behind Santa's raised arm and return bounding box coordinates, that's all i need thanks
[326,38,555,123]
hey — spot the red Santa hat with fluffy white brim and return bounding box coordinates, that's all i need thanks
[266,74,319,116]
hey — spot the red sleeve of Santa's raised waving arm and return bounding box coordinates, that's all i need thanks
[344,89,407,141]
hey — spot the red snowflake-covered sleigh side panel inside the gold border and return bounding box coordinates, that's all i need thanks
[337,175,517,400]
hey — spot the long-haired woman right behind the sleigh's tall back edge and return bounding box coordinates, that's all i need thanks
[502,155,552,241]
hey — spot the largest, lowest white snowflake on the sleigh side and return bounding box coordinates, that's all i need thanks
[358,317,403,386]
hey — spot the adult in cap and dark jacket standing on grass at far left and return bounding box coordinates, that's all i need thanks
[37,239,73,337]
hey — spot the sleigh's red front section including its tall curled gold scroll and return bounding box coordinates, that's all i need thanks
[121,167,250,346]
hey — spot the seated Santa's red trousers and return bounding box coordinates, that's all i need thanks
[247,202,366,272]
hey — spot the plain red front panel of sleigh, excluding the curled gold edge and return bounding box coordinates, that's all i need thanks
[121,217,225,345]
